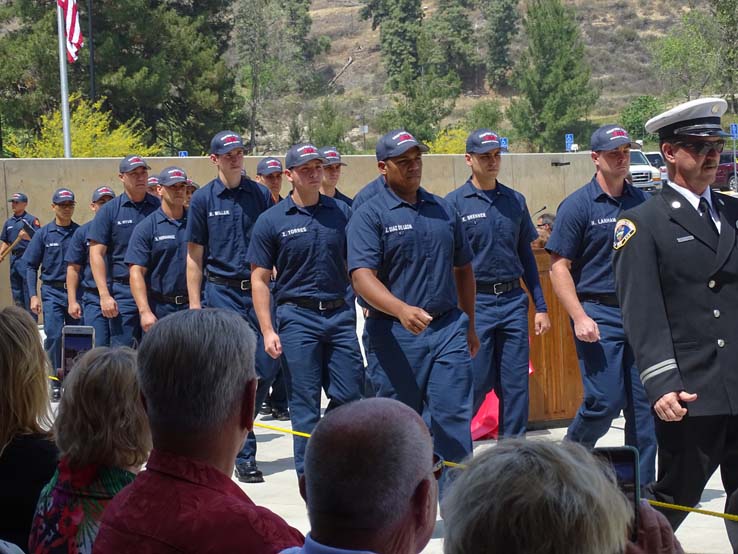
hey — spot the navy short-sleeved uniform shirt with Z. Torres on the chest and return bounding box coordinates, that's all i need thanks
[248,194,351,303]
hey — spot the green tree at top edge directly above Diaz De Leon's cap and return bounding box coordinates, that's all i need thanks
[361,0,423,91]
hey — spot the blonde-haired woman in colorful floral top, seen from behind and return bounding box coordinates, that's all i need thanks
[29,347,151,554]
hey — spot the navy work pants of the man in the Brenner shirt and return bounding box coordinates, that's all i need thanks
[472,288,530,437]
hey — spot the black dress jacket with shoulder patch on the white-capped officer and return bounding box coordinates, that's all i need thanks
[613,186,738,416]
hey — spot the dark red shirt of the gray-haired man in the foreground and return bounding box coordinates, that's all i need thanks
[93,450,304,554]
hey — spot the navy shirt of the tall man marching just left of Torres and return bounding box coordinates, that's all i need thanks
[187,177,274,279]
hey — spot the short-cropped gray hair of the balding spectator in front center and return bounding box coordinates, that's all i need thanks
[305,398,433,530]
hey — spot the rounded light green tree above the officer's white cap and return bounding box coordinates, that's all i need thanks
[654,9,722,100]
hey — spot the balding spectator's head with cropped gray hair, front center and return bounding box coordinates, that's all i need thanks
[300,398,438,554]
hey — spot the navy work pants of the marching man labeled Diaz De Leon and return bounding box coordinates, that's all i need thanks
[366,309,473,489]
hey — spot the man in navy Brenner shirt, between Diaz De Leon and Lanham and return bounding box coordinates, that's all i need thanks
[446,129,551,437]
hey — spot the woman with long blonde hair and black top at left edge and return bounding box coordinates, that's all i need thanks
[0,306,57,547]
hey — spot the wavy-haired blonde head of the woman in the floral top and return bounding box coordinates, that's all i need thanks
[54,348,151,469]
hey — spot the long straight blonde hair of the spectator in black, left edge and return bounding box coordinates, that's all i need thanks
[0,306,51,454]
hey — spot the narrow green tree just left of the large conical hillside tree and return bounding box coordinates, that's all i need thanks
[480,0,520,88]
